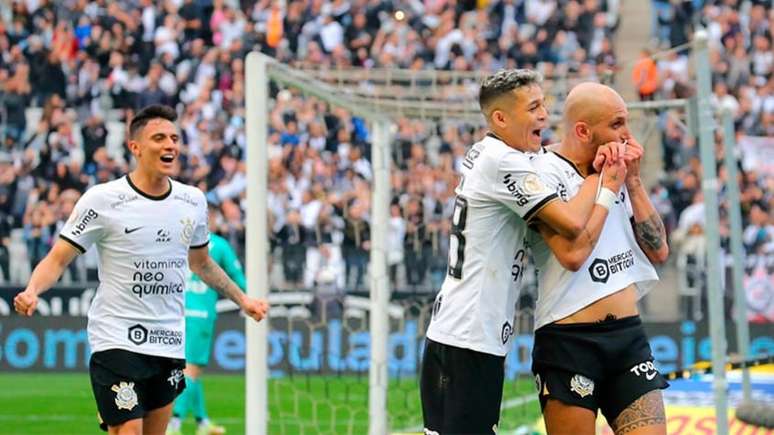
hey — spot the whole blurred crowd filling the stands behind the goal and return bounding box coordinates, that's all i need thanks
[0,0,774,291]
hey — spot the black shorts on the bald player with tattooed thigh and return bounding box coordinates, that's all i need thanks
[532,316,669,421]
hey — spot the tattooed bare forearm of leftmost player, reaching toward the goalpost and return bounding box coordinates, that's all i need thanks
[188,248,269,321]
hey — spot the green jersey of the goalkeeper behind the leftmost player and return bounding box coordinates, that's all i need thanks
[185,234,247,320]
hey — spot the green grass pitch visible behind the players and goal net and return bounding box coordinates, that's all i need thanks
[0,373,539,435]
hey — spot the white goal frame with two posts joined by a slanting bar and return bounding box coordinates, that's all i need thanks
[245,52,391,435]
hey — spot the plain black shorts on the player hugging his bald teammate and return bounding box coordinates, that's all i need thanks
[419,339,505,435]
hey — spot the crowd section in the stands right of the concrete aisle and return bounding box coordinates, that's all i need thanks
[634,0,774,280]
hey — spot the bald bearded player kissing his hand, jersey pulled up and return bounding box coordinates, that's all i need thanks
[529,83,669,435]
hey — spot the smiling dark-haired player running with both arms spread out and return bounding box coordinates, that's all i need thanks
[14,105,268,435]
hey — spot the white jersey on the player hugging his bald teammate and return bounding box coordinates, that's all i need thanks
[427,135,557,356]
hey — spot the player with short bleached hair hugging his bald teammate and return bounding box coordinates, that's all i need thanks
[420,70,625,434]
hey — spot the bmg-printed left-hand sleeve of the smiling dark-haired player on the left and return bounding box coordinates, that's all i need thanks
[59,190,105,254]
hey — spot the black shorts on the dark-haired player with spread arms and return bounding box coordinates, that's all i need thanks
[89,349,185,429]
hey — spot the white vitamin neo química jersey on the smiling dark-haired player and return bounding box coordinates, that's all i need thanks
[60,176,209,358]
